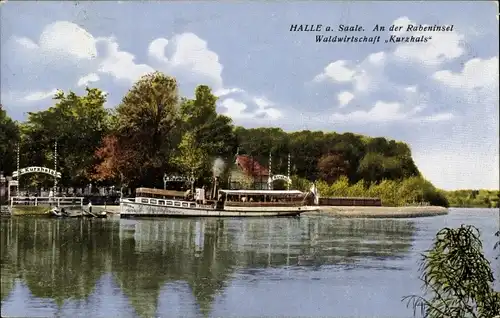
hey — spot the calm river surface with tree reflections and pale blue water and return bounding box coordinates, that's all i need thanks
[1,209,500,317]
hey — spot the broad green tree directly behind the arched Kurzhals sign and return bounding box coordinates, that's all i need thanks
[21,88,108,186]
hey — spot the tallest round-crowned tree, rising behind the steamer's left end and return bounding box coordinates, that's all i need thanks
[104,72,179,186]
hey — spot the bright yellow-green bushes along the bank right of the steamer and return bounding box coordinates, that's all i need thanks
[317,176,448,207]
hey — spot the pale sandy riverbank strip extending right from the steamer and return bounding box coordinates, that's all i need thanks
[303,206,448,218]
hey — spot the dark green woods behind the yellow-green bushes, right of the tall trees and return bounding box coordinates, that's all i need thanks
[235,127,420,184]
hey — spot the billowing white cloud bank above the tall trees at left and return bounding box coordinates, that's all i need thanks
[7,21,282,120]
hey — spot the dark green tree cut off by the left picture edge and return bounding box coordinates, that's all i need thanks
[0,108,19,175]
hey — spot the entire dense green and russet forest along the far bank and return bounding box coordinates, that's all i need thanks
[0,72,498,206]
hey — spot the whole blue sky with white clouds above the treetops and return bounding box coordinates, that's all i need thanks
[0,1,500,189]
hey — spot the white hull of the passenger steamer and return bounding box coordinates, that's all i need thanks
[120,199,319,217]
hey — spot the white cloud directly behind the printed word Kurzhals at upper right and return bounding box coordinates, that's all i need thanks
[393,17,465,66]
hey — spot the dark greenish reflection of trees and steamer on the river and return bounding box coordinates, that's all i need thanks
[1,217,415,317]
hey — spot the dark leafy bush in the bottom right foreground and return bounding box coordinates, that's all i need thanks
[403,225,500,318]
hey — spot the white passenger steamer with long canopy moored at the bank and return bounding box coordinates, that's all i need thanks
[120,180,319,217]
